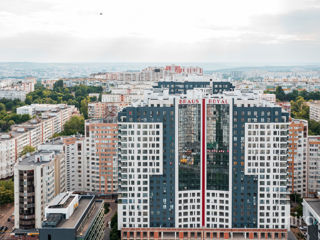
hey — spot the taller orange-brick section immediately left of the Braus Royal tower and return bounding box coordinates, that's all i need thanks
[85,117,118,194]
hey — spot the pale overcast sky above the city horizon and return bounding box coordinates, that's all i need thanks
[0,0,320,64]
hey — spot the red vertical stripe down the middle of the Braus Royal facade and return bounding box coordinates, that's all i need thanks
[201,99,206,227]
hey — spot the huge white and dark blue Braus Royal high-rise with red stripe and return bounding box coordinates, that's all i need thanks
[118,88,290,237]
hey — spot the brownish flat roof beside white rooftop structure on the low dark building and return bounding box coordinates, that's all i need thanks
[57,197,93,228]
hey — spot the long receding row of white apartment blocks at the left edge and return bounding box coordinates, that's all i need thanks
[0,104,77,179]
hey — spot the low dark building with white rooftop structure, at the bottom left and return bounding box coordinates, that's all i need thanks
[39,192,104,240]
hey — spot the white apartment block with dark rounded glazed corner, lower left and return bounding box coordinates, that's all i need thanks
[14,150,66,231]
